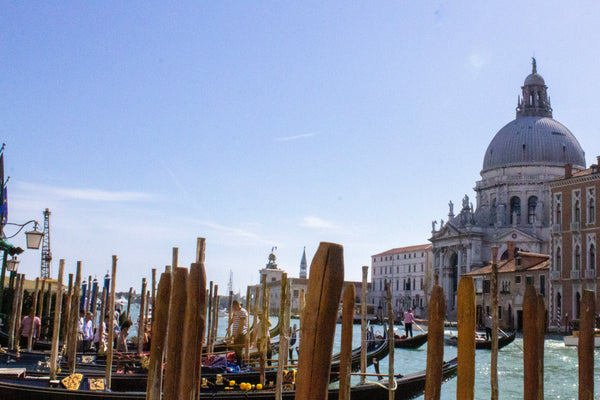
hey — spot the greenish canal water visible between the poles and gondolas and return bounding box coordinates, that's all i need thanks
[127,306,600,400]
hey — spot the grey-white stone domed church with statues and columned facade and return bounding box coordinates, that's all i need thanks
[429,59,586,318]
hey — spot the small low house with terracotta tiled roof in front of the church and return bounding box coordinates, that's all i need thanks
[464,248,550,331]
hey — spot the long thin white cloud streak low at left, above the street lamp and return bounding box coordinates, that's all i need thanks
[19,182,152,203]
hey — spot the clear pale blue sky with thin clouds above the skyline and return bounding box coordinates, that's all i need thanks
[0,1,600,294]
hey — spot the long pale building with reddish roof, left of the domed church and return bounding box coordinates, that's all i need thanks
[368,244,432,319]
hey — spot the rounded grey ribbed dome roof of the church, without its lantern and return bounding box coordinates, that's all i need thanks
[483,116,585,172]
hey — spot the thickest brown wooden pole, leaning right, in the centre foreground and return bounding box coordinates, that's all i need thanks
[296,242,344,400]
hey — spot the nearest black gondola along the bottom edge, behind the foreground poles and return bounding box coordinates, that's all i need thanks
[0,359,457,400]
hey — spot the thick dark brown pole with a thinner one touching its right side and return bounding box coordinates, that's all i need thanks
[523,285,539,400]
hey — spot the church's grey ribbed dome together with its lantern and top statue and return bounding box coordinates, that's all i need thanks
[482,58,585,172]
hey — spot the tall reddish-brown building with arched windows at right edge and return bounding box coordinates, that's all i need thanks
[549,157,600,330]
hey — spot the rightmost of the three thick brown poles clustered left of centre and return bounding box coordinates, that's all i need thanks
[179,238,206,400]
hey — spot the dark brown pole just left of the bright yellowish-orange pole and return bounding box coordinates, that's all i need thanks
[425,285,446,400]
